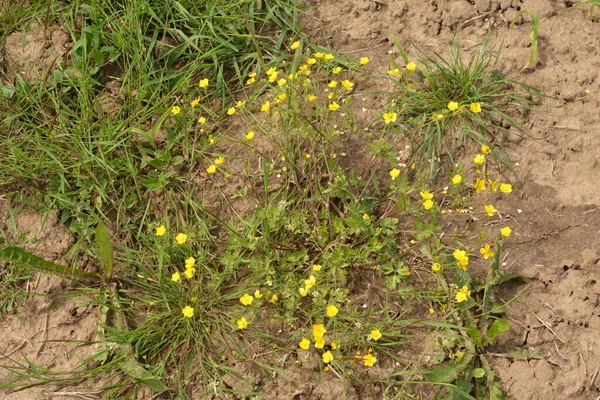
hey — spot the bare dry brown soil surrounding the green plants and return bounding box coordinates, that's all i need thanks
[0,0,600,400]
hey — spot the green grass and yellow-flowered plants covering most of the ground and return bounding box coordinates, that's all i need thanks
[0,1,535,399]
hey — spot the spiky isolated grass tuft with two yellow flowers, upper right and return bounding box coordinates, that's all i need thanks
[390,37,542,175]
